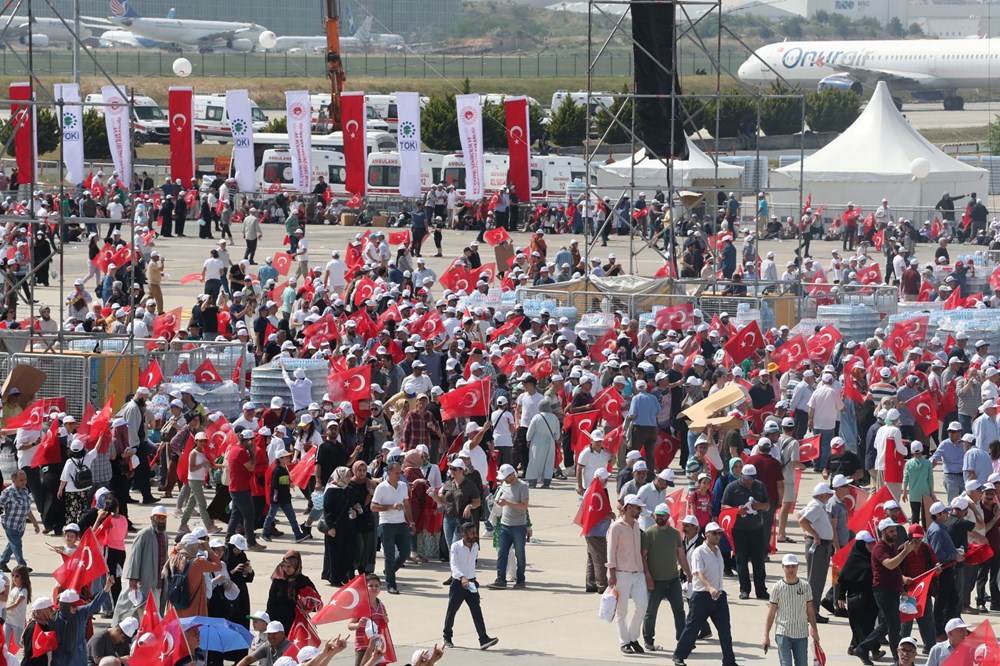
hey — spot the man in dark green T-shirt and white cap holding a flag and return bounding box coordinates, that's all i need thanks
[642,504,691,652]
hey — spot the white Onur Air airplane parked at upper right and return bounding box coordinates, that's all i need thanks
[738,39,1000,111]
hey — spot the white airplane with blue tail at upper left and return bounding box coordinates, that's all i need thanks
[111,0,267,53]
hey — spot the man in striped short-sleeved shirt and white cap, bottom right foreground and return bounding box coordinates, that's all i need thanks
[763,553,819,666]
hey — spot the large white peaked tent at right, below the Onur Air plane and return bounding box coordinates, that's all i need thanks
[770,82,989,212]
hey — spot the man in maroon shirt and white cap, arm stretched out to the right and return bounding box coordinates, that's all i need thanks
[854,518,917,664]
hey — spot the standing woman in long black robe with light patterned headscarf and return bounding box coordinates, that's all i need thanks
[323,467,358,585]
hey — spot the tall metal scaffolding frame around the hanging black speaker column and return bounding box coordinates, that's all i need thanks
[584,0,806,280]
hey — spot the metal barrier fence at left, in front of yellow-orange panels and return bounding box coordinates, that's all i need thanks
[0,331,247,418]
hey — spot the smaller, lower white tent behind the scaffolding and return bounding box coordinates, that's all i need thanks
[596,137,743,196]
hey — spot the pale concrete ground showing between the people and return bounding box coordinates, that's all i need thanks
[20,226,976,666]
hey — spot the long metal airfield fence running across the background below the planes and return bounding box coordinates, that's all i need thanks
[0,49,747,79]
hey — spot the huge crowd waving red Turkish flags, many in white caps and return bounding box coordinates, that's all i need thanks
[0,176,1000,666]
